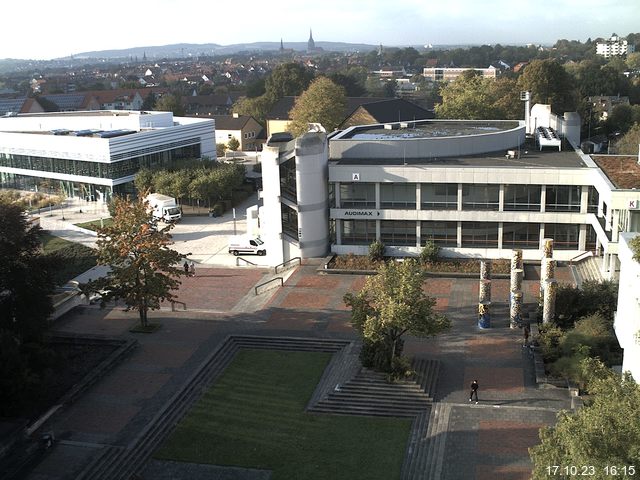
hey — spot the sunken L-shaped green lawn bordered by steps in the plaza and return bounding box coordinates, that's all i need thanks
[155,350,411,480]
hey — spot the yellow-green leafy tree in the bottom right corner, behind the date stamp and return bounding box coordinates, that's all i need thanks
[529,359,640,480]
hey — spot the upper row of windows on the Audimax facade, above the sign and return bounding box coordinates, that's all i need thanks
[332,183,599,213]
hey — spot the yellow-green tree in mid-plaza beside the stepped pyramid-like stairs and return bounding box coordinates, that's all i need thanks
[344,260,451,372]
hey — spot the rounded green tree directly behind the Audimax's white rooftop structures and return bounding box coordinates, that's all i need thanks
[518,60,576,112]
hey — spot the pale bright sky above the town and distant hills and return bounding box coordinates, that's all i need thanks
[0,0,640,59]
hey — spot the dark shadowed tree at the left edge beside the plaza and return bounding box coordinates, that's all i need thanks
[0,198,54,345]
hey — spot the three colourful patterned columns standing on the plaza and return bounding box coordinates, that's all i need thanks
[478,238,557,329]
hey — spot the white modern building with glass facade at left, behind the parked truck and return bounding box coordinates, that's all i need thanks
[0,110,216,201]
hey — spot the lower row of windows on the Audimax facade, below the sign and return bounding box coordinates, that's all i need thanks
[337,220,596,250]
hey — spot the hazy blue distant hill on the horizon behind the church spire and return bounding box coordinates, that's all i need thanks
[73,42,378,59]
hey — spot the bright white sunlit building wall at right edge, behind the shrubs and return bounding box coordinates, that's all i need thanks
[614,233,640,382]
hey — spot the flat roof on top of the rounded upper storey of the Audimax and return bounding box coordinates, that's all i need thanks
[339,120,519,140]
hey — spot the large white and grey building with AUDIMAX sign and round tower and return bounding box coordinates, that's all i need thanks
[261,105,640,278]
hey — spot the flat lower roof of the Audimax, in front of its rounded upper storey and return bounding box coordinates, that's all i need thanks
[329,139,588,168]
